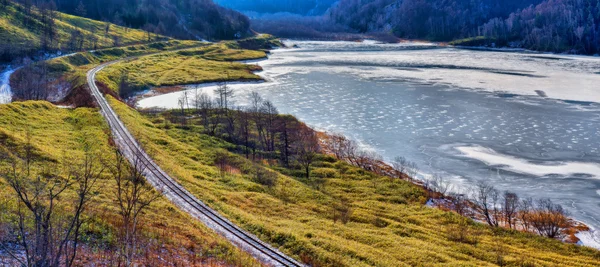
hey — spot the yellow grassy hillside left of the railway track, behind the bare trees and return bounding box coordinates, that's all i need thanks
[0,101,260,267]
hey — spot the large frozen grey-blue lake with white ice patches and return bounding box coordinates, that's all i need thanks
[139,42,600,247]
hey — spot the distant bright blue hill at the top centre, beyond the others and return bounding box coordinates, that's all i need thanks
[215,0,338,16]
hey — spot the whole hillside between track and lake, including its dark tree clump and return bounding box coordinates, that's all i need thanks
[103,93,600,266]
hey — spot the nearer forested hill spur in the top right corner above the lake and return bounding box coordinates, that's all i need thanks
[480,0,600,54]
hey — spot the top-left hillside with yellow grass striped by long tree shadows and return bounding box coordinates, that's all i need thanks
[0,1,162,62]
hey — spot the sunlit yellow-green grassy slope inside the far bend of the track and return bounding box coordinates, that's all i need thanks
[98,43,266,92]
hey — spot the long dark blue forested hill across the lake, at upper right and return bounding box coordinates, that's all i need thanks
[327,0,600,54]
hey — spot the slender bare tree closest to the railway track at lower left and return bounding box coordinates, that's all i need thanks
[111,151,160,266]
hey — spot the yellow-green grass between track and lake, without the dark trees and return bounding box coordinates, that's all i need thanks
[110,98,600,266]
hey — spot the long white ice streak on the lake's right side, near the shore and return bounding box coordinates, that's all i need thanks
[456,146,600,178]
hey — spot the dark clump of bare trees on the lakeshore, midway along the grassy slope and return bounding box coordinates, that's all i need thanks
[165,83,320,178]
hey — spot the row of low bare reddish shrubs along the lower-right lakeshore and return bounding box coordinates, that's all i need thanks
[324,130,574,241]
